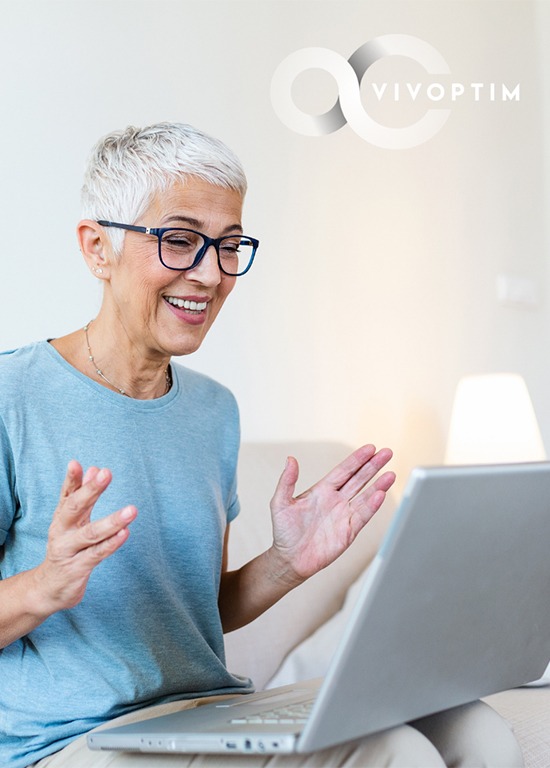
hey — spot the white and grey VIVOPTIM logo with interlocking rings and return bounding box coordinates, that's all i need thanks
[271,34,519,149]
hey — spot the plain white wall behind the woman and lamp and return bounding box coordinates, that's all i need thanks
[0,0,550,492]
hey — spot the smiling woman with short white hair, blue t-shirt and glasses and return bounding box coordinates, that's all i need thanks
[0,124,521,768]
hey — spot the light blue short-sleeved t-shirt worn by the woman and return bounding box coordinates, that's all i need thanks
[0,341,251,768]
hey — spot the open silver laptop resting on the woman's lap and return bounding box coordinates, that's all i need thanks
[88,462,550,754]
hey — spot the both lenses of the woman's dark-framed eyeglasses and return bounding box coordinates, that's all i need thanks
[160,229,254,275]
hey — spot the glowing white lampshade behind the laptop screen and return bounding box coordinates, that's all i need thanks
[445,373,546,464]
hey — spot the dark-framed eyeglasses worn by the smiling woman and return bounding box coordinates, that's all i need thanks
[97,220,260,277]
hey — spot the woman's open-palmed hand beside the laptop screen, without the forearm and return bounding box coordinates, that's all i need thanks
[271,445,395,583]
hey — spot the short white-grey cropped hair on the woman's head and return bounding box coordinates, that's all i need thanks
[82,123,247,255]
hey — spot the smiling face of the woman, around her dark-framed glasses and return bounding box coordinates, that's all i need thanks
[108,177,243,357]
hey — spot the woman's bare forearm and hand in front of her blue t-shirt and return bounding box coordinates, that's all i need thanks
[0,461,137,648]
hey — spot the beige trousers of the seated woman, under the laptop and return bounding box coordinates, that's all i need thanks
[29,697,524,768]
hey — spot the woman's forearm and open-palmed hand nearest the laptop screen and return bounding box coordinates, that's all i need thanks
[219,445,395,632]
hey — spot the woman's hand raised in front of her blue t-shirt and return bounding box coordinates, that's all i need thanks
[34,460,137,616]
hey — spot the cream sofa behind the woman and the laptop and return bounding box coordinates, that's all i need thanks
[225,442,550,768]
